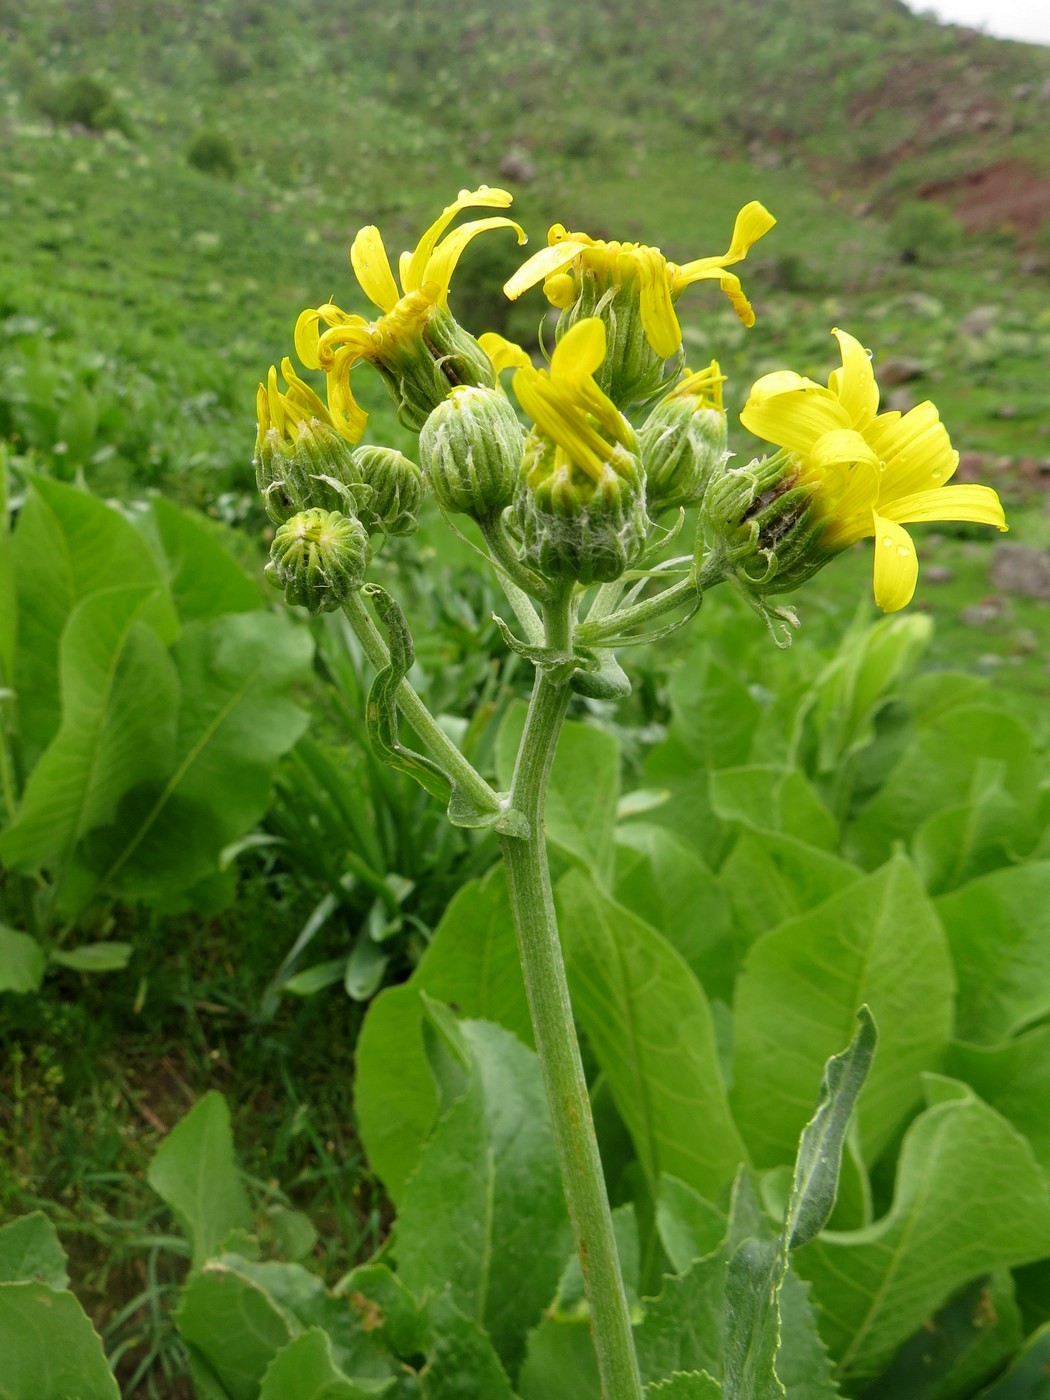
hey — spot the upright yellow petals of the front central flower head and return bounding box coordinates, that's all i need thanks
[514,318,636,483]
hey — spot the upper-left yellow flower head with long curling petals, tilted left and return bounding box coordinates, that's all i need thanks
[295,185,525,442]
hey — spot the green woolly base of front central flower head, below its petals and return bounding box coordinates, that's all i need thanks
[514,433,650,584]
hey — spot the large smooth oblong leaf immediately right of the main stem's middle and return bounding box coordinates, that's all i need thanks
[556,872,743,1196]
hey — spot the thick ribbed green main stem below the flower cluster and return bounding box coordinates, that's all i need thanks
[501,598,641,1400]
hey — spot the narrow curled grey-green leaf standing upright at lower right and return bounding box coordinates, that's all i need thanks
[784,1007,878,1249]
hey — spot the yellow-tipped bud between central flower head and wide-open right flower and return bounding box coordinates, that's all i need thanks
[638,360,729,519]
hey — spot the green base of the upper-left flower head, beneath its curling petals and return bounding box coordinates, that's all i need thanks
[372,303,496,433]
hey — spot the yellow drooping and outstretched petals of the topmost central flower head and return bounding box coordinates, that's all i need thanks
[504,200,776,360]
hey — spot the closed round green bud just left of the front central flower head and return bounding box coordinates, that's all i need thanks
[419,388,525,521]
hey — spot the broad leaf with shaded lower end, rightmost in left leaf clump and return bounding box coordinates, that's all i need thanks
[77,612,312,900]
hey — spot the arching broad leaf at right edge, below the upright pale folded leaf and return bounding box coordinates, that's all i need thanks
[847,706,1037,867]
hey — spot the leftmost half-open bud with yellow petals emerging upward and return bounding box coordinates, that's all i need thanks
[253,358,358,525]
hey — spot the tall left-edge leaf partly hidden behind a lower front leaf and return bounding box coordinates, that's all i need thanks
[13,477,178,767]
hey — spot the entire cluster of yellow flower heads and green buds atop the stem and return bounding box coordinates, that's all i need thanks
[256,186,1005,610]
